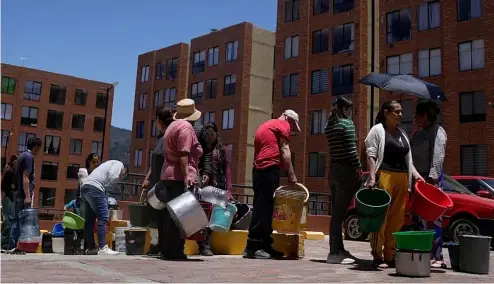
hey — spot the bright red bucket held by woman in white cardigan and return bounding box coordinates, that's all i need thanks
[411,181,453,222]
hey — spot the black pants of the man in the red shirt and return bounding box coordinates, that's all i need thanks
[247,166,280,251]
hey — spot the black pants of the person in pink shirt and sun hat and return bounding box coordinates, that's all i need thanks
[156,180,185,257]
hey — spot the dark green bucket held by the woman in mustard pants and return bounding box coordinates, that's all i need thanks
[355,188,391,233]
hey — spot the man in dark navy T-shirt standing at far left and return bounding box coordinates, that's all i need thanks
[9,137,43,250]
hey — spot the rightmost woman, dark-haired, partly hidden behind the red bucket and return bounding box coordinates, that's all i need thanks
[411,101,448,268]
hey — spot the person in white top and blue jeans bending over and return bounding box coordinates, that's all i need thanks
[81,160,127,255]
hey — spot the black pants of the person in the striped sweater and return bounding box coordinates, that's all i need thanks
[329,161,361,254]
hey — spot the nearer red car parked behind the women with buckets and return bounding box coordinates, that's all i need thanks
[344,173,494,245]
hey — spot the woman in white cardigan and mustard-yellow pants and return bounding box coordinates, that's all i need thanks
[365,101,424,269]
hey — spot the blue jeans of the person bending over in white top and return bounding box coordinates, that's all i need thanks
[81,185,109,249]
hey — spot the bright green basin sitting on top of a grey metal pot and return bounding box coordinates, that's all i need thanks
[393,231,434,252]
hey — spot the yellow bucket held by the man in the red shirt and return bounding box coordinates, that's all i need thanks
[273,183,309,234]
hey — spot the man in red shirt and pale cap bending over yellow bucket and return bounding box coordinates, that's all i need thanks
[244,110,300,259]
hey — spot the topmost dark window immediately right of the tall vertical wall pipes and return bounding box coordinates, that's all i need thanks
[387,9,412,43]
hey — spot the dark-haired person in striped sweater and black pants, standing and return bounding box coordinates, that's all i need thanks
[324,97,362,264]
